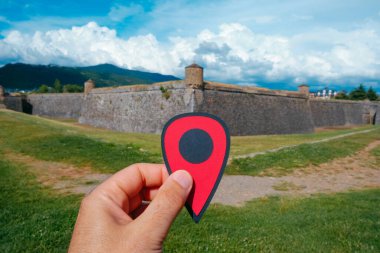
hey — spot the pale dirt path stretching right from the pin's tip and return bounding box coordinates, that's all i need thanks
[212,141,380,205]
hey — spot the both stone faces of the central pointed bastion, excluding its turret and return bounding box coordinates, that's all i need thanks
[79,82,314,135]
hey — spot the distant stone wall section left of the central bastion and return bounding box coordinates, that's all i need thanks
[27,93,83,119]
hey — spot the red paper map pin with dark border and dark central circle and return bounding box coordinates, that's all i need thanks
[161,113,230,223]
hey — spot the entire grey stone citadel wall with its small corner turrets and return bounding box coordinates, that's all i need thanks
[4,64,380,135]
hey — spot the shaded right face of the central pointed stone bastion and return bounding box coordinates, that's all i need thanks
[195,87,314,135]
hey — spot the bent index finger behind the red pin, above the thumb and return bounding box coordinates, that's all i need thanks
[91,163,168,213]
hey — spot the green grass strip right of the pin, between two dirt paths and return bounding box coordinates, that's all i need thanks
[226,128,380,176]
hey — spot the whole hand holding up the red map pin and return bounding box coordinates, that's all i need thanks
[69,164,193,253]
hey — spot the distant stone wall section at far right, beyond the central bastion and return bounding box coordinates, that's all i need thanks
[310,99,380,127]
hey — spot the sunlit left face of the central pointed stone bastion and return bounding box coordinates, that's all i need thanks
[79,85,192,133]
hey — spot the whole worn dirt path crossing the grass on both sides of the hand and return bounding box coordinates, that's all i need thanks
[5,141,380,206]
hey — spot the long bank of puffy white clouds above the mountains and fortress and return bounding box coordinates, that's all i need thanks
[0,22,380,90]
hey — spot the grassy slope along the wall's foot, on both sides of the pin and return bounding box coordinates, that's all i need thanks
[0,111,380,175]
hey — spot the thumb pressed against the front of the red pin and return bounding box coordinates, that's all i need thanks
[139,170,193,241]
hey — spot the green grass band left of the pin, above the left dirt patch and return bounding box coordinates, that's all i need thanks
[0,109,161,172]
